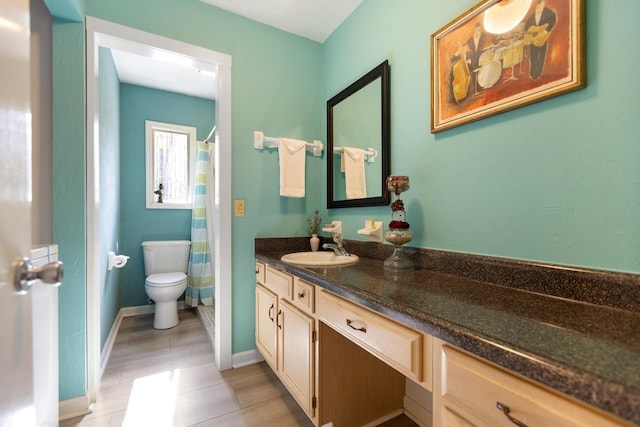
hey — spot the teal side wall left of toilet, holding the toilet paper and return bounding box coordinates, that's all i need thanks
[98,48,122,349]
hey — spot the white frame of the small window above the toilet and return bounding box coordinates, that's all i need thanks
[145,120,198,209]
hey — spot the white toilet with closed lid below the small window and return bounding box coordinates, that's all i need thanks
[142,240,191,329]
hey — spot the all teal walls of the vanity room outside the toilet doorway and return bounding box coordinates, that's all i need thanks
[54,0,640,400]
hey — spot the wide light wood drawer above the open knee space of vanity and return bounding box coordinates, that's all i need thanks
[318,291,424,382]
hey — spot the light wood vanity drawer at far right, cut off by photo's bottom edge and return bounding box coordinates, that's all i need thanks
[441,345,622,427]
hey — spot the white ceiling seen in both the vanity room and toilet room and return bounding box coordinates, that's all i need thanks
[111,0,363,99]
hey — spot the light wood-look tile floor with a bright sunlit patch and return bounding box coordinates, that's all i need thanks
[60,310,416,427]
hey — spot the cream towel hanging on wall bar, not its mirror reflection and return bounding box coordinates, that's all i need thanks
[278,138,307,197]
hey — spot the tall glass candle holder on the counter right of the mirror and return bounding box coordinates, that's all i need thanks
[384,175,415,271]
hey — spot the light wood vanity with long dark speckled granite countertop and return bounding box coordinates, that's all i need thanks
[256,239,640,427]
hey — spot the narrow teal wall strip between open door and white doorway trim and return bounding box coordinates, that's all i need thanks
[52,19,87,400]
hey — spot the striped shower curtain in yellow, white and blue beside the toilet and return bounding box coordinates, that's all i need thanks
[185,142,215,307]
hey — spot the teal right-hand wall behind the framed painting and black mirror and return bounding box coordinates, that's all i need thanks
[323,0,640,273]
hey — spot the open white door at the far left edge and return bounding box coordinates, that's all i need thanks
[0,0,35,427]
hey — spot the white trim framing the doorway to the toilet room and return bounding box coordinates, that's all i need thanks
[86,16,233,403]
